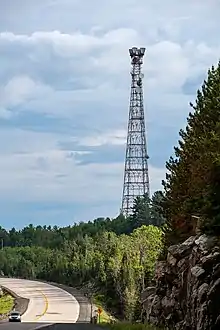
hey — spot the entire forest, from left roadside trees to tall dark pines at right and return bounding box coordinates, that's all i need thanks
[0,62,220,321]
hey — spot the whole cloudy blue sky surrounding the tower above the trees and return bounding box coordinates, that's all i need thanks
[0,0,220,229]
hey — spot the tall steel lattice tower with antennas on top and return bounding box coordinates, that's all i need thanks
[121,47,150,216]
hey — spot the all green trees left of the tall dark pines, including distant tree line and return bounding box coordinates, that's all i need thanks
[0,196,163,321]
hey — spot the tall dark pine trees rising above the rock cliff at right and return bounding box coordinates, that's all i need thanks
[163,62,220,244]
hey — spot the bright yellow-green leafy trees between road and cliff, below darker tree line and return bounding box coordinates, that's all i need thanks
[0,226,162,320]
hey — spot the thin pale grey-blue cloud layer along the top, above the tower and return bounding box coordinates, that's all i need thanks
[0,0,219,42]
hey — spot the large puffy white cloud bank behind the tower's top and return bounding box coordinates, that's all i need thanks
[0,28,220,122]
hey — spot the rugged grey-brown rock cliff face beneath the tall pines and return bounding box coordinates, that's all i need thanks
[142,235,220,330]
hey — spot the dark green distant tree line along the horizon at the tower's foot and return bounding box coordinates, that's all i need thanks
[0,191,164,248]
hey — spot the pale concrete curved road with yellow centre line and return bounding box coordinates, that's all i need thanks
[0,278,80,324]
